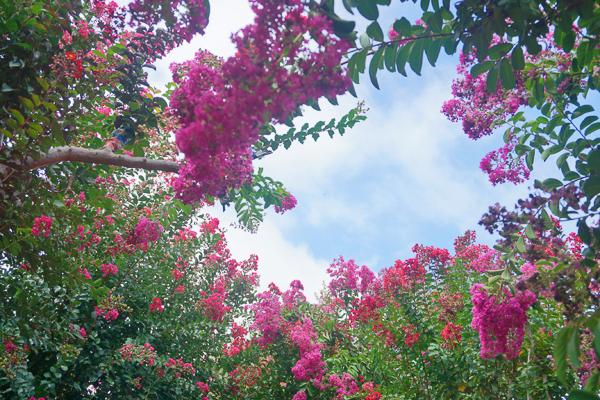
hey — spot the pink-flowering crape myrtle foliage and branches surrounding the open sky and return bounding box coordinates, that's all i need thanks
[0,0,600,400]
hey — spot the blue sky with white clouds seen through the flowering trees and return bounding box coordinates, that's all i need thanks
[120,0,580,299]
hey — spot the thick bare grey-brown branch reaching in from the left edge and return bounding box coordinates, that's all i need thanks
[3,146,179,173]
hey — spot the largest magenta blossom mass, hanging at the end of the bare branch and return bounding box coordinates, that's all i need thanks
[170,0,351,205]
